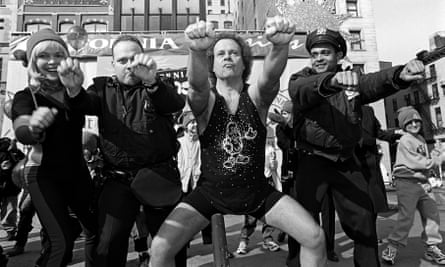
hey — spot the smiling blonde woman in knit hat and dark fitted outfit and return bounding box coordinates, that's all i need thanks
[12,29,96,267]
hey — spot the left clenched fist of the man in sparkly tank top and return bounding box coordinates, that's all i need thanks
[184,20,215,51]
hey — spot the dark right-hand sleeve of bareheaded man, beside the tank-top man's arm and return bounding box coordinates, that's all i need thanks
[151,78,185,114]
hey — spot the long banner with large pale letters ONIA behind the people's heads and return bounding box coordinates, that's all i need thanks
[10,31,309,58]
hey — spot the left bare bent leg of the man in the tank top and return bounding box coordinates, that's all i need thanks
[150,203,209,267]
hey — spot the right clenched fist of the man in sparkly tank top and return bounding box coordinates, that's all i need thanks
[265,16,295,45]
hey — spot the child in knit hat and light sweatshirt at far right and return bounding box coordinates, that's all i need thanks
[382,106,445,265]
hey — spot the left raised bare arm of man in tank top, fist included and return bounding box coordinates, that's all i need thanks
[185,21,215,120]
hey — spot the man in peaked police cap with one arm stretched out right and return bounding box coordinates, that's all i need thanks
[288,29,424,267]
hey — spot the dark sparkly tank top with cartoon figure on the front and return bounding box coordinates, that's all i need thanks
[198,85,268,214]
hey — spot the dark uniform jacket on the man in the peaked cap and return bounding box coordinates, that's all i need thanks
[288,66,409,161]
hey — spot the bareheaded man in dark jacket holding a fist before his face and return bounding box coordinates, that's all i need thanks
[59,35,186,267]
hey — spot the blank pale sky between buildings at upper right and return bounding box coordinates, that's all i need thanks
[371,0,445,65]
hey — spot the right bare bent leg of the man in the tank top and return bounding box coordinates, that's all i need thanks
[265,196,326,267]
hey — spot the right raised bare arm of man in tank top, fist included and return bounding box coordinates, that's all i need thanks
[249,16,295,115]
